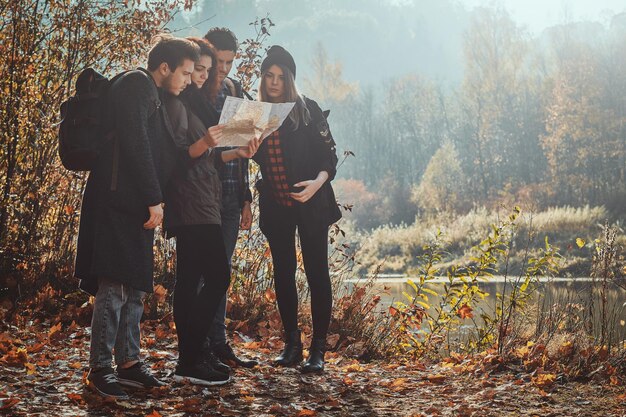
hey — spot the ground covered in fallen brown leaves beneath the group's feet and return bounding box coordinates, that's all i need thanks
[0,322,626,417]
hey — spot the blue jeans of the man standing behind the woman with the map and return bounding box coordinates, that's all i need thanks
[209,193,241,345]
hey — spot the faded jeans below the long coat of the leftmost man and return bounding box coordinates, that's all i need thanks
[89,278,146,369]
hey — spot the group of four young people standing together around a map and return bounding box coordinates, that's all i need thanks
[75,28,341,399]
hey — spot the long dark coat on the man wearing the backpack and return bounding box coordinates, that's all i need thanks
[75,69,175,295]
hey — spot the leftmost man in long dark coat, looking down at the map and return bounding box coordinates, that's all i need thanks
[75,36,199,398]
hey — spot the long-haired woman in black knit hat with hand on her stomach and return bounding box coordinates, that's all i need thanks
[254,46,341,372]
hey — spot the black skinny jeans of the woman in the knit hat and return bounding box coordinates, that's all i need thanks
[264,208,333,339]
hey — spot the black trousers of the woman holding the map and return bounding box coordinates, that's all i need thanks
[174,224,230,365]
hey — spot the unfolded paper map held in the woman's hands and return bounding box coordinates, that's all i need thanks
[218,96,295,147]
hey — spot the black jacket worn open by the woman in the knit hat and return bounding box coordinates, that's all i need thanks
[254,98,341,234]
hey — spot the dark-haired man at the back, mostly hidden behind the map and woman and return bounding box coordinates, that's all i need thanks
[204,27,257,368]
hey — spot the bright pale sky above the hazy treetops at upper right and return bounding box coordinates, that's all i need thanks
[459,0,626,34]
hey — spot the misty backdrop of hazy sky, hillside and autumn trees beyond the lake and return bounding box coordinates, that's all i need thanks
[171,0,626,234]
